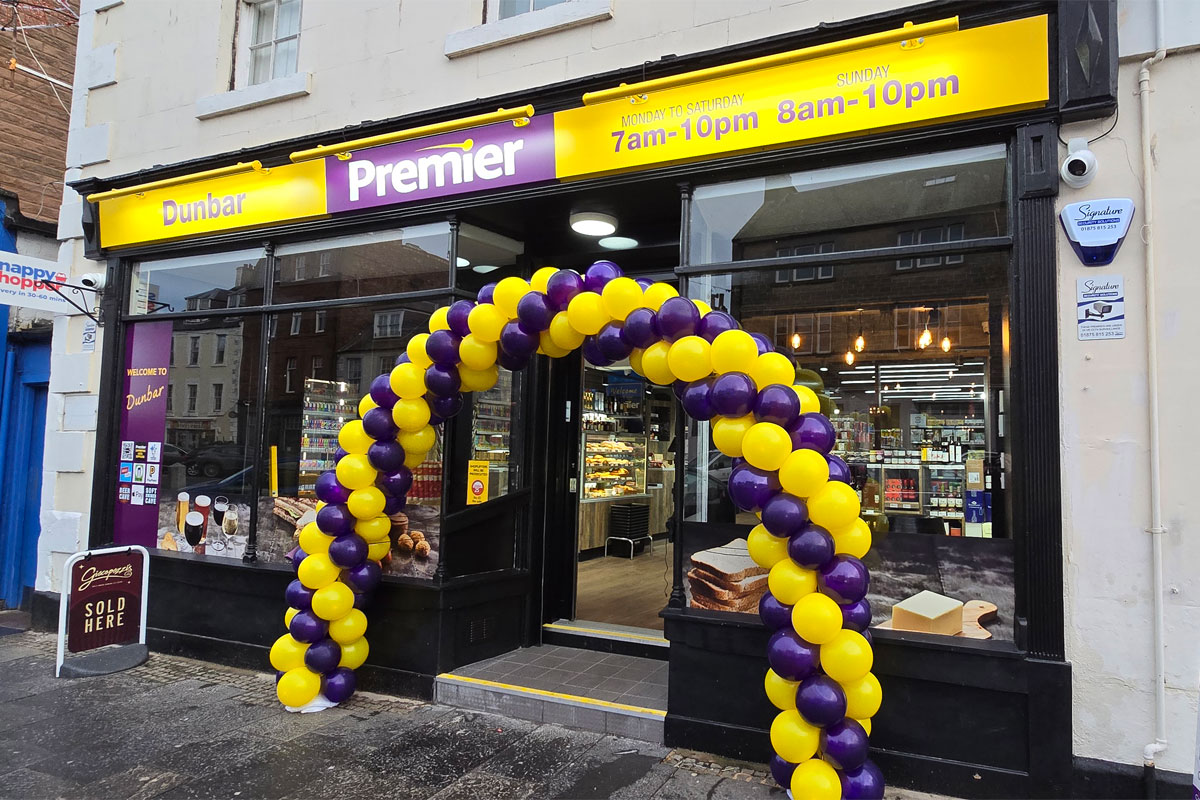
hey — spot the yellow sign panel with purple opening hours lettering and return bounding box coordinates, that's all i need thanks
[554,16,1050,179]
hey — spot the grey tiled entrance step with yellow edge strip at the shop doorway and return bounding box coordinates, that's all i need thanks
[437,645,667,744]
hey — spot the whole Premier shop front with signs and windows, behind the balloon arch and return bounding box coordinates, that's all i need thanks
[60,4,1115,796]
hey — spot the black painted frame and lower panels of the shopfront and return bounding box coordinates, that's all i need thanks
[56,0,1116,796]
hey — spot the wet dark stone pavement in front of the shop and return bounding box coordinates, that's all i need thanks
[0,628,932,800]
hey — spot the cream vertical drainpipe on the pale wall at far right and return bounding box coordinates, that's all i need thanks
[1138,0,1166,798]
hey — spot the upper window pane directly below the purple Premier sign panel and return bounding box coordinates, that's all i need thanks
[275,222,450,302]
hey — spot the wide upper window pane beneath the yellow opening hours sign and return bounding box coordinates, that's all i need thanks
[691,145,1008,269]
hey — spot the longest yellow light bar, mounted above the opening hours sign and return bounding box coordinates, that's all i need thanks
[583,17,959,106]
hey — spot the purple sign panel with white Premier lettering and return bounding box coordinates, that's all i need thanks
[325,115,554,213]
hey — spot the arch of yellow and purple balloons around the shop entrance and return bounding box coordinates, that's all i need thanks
[271,261,883,799]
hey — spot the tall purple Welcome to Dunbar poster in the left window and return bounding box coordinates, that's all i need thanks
[113,323,173,547]
